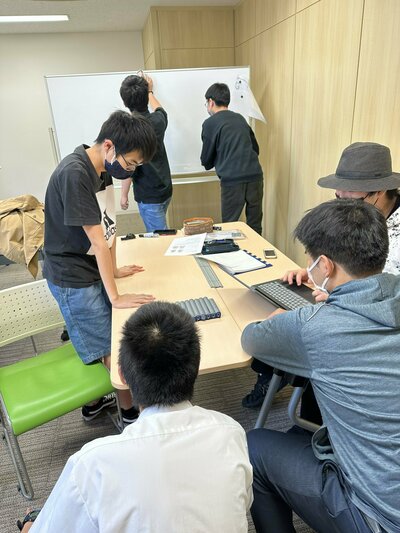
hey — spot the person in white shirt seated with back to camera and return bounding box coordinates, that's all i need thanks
[23,302,253,533]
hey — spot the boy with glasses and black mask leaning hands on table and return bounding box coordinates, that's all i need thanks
[43,111,156,423]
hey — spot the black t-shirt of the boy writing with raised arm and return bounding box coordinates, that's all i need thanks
[132,107,172,204]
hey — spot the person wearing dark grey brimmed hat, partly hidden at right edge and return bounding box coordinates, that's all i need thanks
[242,142,400,412]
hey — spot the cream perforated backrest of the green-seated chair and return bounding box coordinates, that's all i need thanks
[0,280,64,346]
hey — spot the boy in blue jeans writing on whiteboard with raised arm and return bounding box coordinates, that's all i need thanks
[120,75,172,232]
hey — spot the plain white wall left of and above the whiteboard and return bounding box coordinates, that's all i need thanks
[0,32,143,201]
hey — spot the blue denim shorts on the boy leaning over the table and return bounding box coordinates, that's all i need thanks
[47,280,111,364]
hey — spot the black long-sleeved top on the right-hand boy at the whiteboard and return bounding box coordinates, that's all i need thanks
[201,109,263,185]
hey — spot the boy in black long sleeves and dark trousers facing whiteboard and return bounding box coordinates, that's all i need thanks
[201,83,264,235]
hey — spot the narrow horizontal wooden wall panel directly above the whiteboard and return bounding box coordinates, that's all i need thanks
[161,47,235,68]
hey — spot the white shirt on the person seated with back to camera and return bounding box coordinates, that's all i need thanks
[31,402,252,533]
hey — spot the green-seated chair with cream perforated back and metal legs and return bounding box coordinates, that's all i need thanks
[0,280,114,499]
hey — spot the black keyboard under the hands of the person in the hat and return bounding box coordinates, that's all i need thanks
[251,280,315,311]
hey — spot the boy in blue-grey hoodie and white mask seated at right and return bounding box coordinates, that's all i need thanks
[242,199,400,533]
